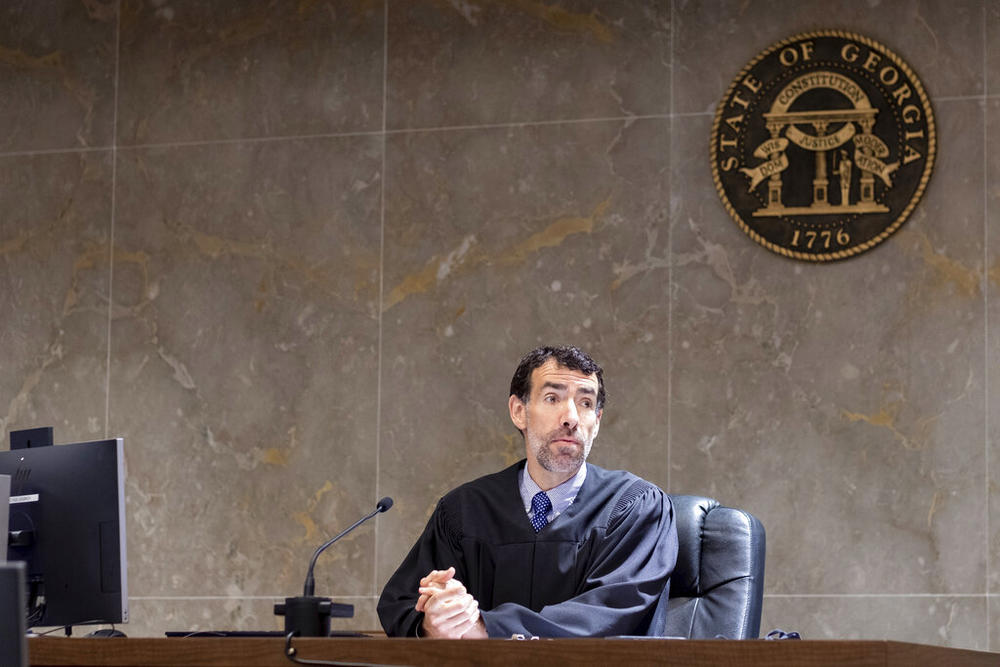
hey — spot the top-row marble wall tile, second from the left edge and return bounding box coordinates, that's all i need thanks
[118,0,384,145]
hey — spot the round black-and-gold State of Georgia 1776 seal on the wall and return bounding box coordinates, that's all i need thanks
[711,30,937,262]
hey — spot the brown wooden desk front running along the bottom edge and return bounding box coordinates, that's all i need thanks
[28,637,1000,667]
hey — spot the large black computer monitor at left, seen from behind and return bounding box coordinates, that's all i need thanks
[0,438,128,627]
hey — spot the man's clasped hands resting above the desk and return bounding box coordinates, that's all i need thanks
[414,567,488,639]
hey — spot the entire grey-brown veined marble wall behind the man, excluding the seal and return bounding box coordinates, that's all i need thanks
[0,0,1000,650]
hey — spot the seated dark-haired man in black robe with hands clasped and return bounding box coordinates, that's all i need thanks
[378,347,677,639]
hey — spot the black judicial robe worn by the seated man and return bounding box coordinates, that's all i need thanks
[378,460,677,637]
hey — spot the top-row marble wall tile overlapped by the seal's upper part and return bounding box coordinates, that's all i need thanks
[673,0,984,113]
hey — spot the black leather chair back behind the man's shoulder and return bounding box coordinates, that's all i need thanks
[650,495,765,639]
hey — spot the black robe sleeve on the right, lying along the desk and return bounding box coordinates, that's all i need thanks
[480,483,677,638]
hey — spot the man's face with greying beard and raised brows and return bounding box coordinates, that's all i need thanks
[510,359,601,482]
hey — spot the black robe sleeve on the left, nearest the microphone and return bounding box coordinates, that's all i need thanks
[377,501,466,637]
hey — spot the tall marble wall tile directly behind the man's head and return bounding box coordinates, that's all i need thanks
[378,120,669,582]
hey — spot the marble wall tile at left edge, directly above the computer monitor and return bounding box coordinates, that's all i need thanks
[0,152,112,449]
